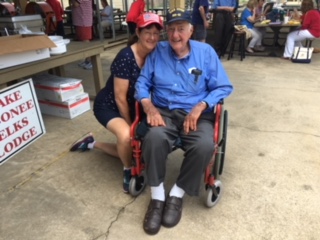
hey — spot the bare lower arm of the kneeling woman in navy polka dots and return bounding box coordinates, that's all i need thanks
[113,77,131,125]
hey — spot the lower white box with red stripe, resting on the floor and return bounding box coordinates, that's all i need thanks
[38,93,90,119]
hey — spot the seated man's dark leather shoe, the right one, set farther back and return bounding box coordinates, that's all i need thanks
[162,196,182,227]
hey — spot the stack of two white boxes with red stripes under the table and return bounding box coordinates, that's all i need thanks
[32,73,90,119]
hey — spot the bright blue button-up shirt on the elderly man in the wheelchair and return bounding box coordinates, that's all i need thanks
[135,40,233,112]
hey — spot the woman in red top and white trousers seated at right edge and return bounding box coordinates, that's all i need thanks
[282,0,320,60]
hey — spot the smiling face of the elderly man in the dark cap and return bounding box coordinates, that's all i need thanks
[167,21,193,54]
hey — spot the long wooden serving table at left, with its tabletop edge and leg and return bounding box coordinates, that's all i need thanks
[0,41,105,99]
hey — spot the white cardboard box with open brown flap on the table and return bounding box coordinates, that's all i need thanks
[0,35,56,69]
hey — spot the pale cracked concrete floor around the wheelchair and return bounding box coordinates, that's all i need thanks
[0,39,320,240]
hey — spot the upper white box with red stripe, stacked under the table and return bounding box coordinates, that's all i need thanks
[32,73,83,102]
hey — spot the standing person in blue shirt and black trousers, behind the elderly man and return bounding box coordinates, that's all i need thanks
[213,0,238,57]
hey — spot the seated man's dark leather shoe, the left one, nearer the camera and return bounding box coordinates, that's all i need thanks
[143,199,164,235]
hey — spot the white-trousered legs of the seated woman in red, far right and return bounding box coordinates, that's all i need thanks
[283,30,314,58]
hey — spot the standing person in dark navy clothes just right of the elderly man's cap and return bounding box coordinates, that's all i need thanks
[192,0,209,42]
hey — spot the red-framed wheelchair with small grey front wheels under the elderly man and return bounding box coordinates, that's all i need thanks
[129,100,228,207]
